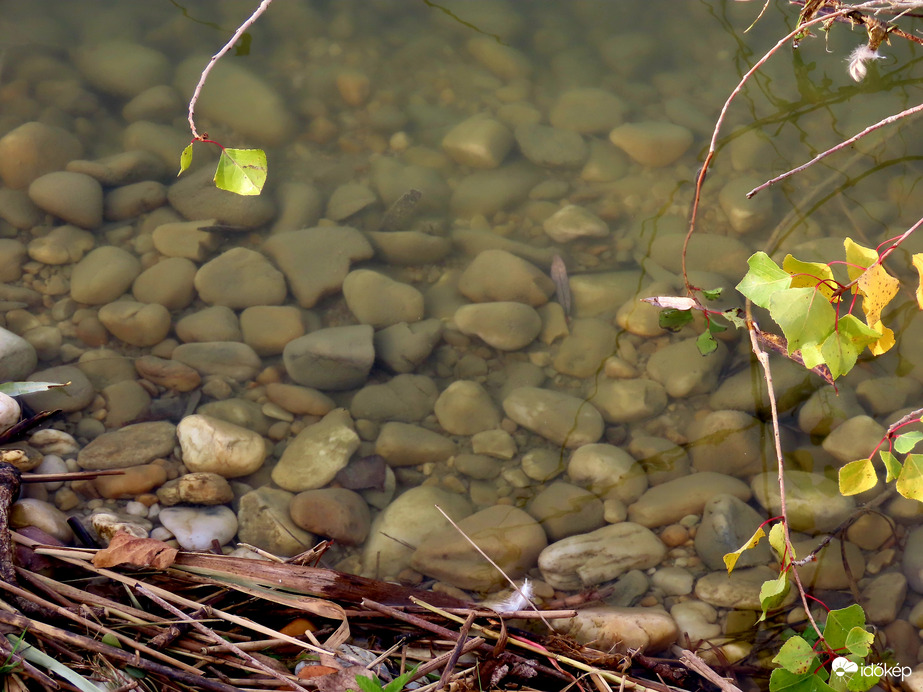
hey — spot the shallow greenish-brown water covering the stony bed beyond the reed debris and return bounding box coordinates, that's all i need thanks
[0,0,921,680]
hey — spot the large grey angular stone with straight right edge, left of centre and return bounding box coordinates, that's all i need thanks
[282,325,375,391]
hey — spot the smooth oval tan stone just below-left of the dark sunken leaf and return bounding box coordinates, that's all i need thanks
[454,301,542,351]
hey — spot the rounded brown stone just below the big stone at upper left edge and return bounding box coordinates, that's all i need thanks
[29,171,103,229]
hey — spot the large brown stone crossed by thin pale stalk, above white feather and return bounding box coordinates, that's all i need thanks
[410,505,547,591]
